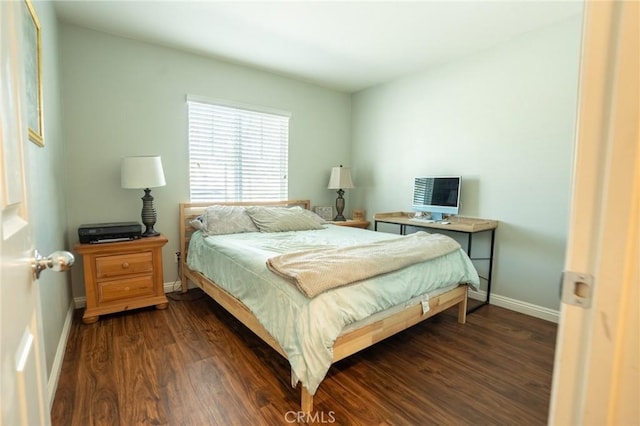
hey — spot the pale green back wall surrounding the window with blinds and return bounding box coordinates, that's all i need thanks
[60,24,351,297]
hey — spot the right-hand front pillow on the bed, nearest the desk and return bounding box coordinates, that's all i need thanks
[247,206,324,232]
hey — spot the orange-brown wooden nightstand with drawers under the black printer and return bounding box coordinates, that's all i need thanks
[74,235,168,324]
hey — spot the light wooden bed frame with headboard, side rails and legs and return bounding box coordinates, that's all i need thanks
[180,200,467,413]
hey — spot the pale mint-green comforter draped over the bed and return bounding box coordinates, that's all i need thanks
[187,225,479,395]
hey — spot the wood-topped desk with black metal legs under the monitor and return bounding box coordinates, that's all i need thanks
[373,212,498,313]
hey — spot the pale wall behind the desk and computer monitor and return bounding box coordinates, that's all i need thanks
[351,17,581,310]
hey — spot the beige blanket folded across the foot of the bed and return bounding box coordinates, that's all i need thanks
[267,231,460,298]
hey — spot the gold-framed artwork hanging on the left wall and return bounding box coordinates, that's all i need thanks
[22,0,44,146]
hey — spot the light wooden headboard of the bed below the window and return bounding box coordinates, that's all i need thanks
[179,200,311,290]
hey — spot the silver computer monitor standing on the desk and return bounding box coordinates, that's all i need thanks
[411,176,462,220]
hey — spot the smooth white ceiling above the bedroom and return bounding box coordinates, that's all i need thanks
[54,0,582,92]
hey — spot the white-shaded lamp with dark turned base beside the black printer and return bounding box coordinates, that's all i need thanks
[120,155,166,237]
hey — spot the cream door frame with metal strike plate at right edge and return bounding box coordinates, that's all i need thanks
[549,1,640,425]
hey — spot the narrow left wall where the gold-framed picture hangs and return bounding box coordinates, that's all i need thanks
[28,2,71,377]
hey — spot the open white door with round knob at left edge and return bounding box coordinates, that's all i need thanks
[0,1,51,426]
